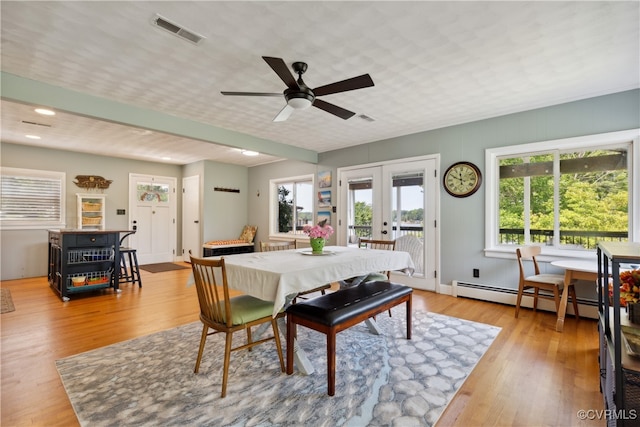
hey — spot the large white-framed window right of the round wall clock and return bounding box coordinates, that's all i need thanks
[487,131,640,256]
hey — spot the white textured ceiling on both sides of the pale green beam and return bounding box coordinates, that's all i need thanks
[0,0,640,166]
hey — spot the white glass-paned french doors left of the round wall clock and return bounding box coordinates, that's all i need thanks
[337,156,439,291]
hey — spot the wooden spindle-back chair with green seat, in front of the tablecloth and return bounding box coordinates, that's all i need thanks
[190,256,285,397]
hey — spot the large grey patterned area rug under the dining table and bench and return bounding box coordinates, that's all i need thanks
[56,307,500,427]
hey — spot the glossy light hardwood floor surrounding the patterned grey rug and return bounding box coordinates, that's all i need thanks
[0,264,604,427]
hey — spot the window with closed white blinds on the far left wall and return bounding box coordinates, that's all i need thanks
[0,168,65,229]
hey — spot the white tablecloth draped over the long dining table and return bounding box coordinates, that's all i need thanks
[195,246,414,316]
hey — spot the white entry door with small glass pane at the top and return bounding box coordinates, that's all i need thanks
[129,174,177,264]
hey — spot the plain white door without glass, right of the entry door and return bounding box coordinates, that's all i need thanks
[182,175,202,262]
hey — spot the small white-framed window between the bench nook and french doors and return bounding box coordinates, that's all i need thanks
[270,175,314,236]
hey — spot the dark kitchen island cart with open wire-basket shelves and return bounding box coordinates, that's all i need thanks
[48,229,120,301]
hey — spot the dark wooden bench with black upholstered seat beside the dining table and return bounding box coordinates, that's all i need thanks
[287,281,413,396]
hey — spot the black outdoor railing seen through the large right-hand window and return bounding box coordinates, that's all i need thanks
[499,228,629,249]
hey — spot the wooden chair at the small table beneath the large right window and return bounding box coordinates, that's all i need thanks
[516,245,580,318]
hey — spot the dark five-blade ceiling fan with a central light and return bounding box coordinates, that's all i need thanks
[220,56,373,122]
